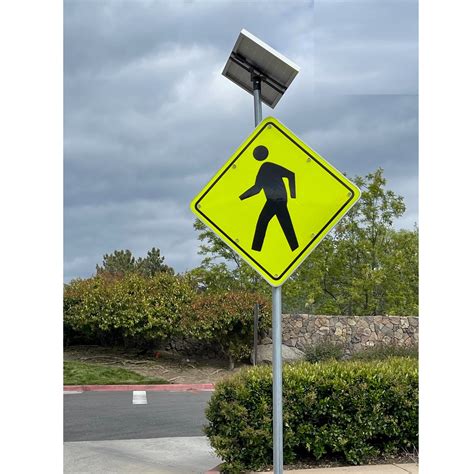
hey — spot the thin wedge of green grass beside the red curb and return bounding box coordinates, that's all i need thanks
[63,360,168,385]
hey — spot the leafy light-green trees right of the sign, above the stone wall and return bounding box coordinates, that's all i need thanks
[287,169,418,315]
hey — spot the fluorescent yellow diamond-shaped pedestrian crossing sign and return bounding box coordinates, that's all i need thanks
[191,117,360,286]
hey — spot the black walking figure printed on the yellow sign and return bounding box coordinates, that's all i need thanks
[239,145,298,252]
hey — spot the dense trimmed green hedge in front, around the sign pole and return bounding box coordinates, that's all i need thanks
[205,358,418,472]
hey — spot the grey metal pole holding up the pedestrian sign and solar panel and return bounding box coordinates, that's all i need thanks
[252,71,283,474]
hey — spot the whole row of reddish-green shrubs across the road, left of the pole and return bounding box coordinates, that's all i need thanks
[64,273,271,360]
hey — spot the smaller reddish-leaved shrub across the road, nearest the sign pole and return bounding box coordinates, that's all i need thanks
[183,291,271,368]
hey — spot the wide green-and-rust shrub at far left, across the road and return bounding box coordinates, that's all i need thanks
[64,273,193,346]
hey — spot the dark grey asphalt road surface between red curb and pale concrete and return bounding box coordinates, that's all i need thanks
[64,391,212,441]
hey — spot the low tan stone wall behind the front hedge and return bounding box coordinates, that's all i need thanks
[262,314,418,353]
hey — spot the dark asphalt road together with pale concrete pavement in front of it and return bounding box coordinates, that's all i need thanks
[64,391,221,474]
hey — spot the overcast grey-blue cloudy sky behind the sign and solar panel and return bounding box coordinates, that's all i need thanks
[64,0,418,281]
